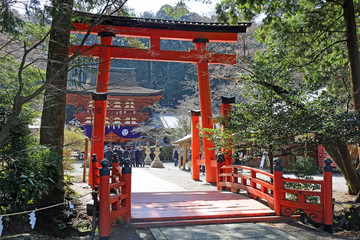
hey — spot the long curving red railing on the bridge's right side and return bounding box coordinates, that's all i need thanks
[218,159,333,232]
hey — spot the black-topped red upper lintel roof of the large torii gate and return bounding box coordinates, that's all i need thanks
[73,11,251,42]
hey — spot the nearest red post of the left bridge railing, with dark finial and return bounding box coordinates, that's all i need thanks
[99,159,111,240]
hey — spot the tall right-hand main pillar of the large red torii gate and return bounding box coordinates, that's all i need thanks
[193,38,216,183]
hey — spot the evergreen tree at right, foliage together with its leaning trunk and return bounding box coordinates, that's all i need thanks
[217,0,360,194]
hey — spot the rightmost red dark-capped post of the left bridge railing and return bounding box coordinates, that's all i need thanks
[121,159,131,223]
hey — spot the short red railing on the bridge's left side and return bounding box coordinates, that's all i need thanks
[92,155,131,239]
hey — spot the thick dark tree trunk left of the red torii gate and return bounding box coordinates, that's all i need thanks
[40,0,73,202]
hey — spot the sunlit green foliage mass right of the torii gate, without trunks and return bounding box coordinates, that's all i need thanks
[214,0,359,154]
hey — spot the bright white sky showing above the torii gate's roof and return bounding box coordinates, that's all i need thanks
[126,0,221,15]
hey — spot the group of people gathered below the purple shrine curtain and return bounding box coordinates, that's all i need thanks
[104,146,146,167]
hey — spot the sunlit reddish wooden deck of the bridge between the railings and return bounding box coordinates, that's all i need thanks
[131,191,275,223]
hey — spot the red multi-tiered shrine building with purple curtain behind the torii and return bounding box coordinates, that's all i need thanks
[66,69,163,145]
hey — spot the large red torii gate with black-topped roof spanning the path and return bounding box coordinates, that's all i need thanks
[70,12,251,182]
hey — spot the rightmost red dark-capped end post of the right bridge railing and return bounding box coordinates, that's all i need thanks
[323,158,333,233]
